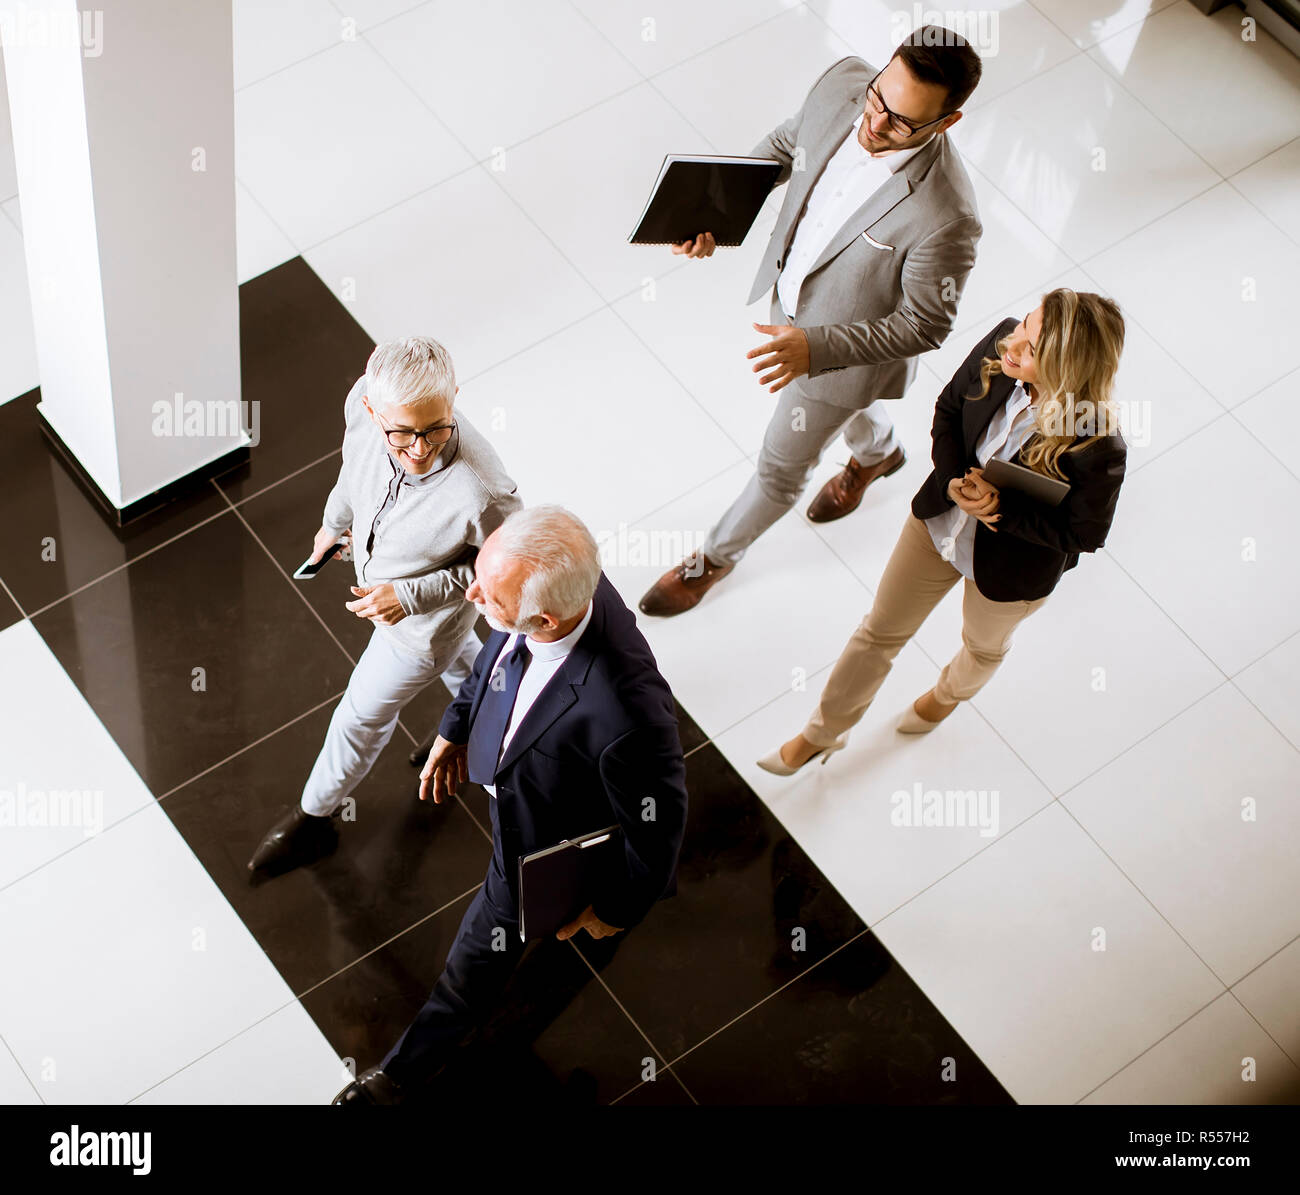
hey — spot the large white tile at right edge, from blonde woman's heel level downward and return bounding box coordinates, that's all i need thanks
[1061,684,1300,987]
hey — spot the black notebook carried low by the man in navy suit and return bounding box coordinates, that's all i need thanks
[519,826,624,941]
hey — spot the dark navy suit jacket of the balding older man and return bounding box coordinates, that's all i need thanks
[438,572,686,928]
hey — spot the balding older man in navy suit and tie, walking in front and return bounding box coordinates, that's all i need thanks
[334,506,686,1105]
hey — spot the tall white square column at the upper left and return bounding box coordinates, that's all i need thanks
[0,0,250,511]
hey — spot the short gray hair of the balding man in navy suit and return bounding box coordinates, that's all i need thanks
[497,506,601,624]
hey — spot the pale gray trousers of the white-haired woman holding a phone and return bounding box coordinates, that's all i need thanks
[303,627,480,817]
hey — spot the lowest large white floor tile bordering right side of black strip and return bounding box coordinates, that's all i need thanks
[874,802,1223,1104]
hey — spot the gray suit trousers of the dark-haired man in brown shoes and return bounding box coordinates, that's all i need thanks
[705,378,900,564]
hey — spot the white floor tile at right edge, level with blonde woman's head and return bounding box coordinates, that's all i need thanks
[1084,183,1300,407]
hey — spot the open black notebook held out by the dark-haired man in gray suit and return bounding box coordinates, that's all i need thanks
[628,153,781,244]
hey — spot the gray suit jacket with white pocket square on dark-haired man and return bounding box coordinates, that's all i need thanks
[748,59,983,410]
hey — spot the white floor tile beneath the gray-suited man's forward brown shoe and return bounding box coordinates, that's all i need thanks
[602,462,868,735]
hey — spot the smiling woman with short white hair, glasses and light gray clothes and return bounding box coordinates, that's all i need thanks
[248,337,521,871]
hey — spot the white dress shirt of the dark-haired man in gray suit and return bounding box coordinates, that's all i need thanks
[776,112,930,316]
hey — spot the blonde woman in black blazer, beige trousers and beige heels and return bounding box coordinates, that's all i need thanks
[758,287,1126,776]
